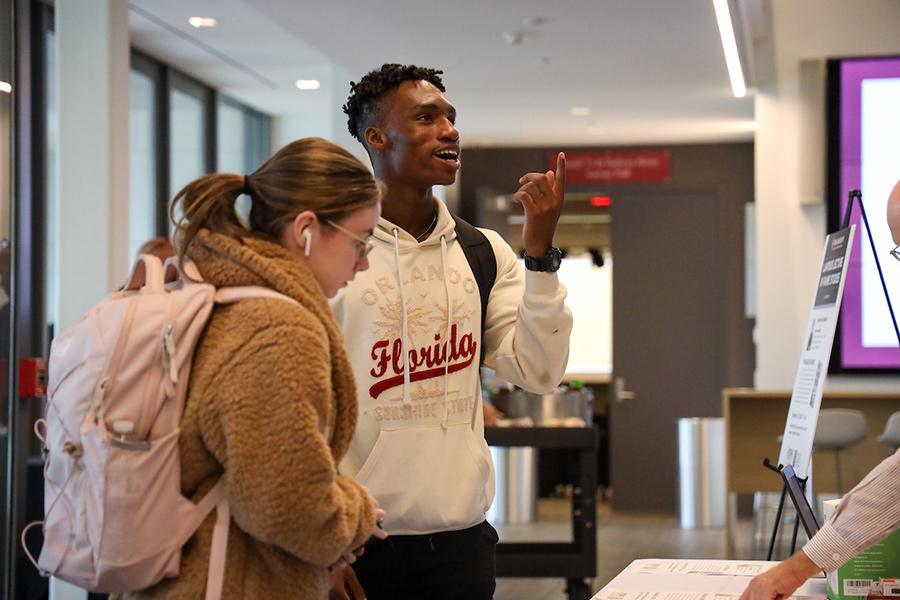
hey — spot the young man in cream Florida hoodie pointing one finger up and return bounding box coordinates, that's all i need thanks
[333,64,572,600]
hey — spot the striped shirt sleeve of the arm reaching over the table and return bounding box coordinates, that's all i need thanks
[803,450,900,572]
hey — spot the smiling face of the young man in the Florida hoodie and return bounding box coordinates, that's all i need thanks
[379,80,460,186]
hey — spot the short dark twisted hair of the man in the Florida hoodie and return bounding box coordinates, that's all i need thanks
[344,63,446,142]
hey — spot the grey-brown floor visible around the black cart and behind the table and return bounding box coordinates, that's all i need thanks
[494,500,751,600]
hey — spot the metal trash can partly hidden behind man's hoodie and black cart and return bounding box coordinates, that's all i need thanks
[487,446,537,523]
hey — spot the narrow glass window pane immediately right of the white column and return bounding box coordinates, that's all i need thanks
[128,70,158,260]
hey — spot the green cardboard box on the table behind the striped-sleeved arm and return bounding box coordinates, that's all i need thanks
[824,500,900,600]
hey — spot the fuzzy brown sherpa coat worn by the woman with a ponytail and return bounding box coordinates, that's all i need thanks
[126,231,375,600]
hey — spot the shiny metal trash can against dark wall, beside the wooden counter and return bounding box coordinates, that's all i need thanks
[678,418,726,529]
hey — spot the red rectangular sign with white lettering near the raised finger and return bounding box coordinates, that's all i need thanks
[547,150,671,183]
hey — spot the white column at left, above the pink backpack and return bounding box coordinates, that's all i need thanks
[51,0,129,329]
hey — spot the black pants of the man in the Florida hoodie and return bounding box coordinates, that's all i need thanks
[353,521,497,600]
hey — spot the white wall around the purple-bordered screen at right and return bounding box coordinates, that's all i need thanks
[755,0,900,389]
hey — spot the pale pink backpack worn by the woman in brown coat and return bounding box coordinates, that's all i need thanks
[22,255,296,600]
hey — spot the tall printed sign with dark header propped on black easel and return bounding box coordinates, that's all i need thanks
[778,225,856,478]
